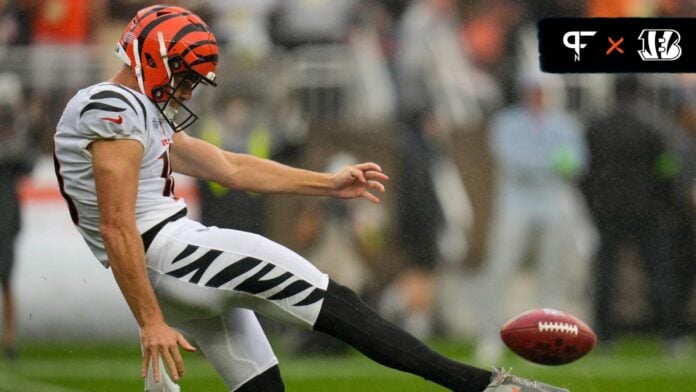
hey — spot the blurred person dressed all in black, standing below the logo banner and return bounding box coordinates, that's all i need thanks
[582,76,684,352]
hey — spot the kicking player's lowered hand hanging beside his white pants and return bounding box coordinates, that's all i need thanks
[140,323,196,382]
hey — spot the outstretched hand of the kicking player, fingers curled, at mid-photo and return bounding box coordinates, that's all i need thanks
[331,162,389,203]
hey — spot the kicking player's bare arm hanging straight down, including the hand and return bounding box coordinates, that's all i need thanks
[89,139,195,382]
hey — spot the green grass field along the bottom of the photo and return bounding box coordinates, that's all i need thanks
[0,338,696,392]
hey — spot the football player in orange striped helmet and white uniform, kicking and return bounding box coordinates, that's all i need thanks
[54,5,559,391]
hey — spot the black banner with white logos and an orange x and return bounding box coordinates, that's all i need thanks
[537,18,696,73]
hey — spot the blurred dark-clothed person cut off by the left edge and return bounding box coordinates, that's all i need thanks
[0,73,32,358]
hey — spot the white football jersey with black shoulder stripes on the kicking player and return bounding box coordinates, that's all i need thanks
[54,83,186,266]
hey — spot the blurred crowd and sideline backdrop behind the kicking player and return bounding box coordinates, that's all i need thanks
[0,0,696,386]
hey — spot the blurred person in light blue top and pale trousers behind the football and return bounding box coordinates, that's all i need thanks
[476,74,586,365]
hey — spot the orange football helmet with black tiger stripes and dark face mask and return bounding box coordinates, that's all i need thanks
[116,5,218,130]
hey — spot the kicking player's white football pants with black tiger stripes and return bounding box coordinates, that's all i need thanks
[146,218,329,390]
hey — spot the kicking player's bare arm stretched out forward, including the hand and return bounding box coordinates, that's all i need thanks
[170,132,389,203]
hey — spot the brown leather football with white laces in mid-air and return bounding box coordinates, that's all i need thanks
[500,309,597,365]
